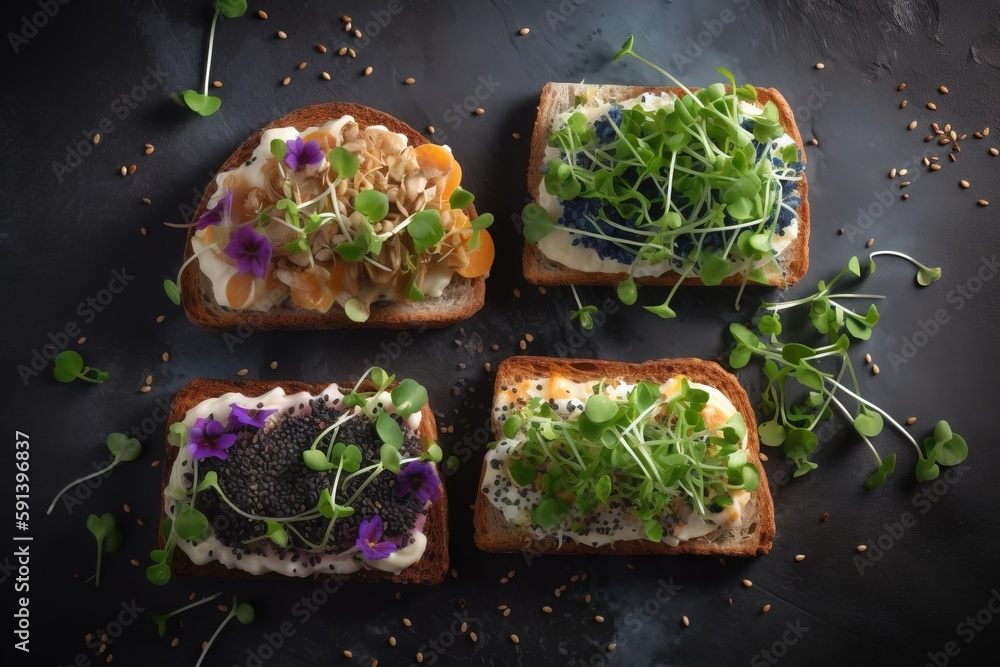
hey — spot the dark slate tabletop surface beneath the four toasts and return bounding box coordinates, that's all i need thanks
[0,0,1000,667]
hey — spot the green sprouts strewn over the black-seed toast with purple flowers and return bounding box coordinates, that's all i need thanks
[146,367,443,585]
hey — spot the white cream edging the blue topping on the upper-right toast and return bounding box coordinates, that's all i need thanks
[534,92,799,278]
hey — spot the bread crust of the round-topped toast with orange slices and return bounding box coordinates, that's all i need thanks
[180,102,486,331]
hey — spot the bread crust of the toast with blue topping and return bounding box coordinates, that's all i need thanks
[523,83,809,287]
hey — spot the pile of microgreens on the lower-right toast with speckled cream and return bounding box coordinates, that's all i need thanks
[490,379,760,541]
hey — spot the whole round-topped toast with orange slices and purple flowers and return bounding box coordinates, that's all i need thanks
[174,103,493,330]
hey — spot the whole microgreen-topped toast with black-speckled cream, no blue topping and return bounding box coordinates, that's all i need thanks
[475,357,775,556]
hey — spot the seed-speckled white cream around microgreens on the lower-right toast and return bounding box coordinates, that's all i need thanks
[480,376,750,547]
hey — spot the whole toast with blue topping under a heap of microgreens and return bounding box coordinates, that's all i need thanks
[523,64,809,317]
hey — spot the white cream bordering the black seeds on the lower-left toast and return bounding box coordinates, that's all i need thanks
[164,384,427,577]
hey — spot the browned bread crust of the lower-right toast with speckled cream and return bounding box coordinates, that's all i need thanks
[473,357,775,556]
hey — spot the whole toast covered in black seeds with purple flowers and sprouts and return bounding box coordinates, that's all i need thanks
[147,368,448,584]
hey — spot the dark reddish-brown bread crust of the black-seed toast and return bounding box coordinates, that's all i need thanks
[160,378,449,584]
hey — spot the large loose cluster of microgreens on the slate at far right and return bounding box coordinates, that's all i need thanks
[729,251,968,489]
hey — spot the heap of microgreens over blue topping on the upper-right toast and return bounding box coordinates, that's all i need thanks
[522,36,805,320]
